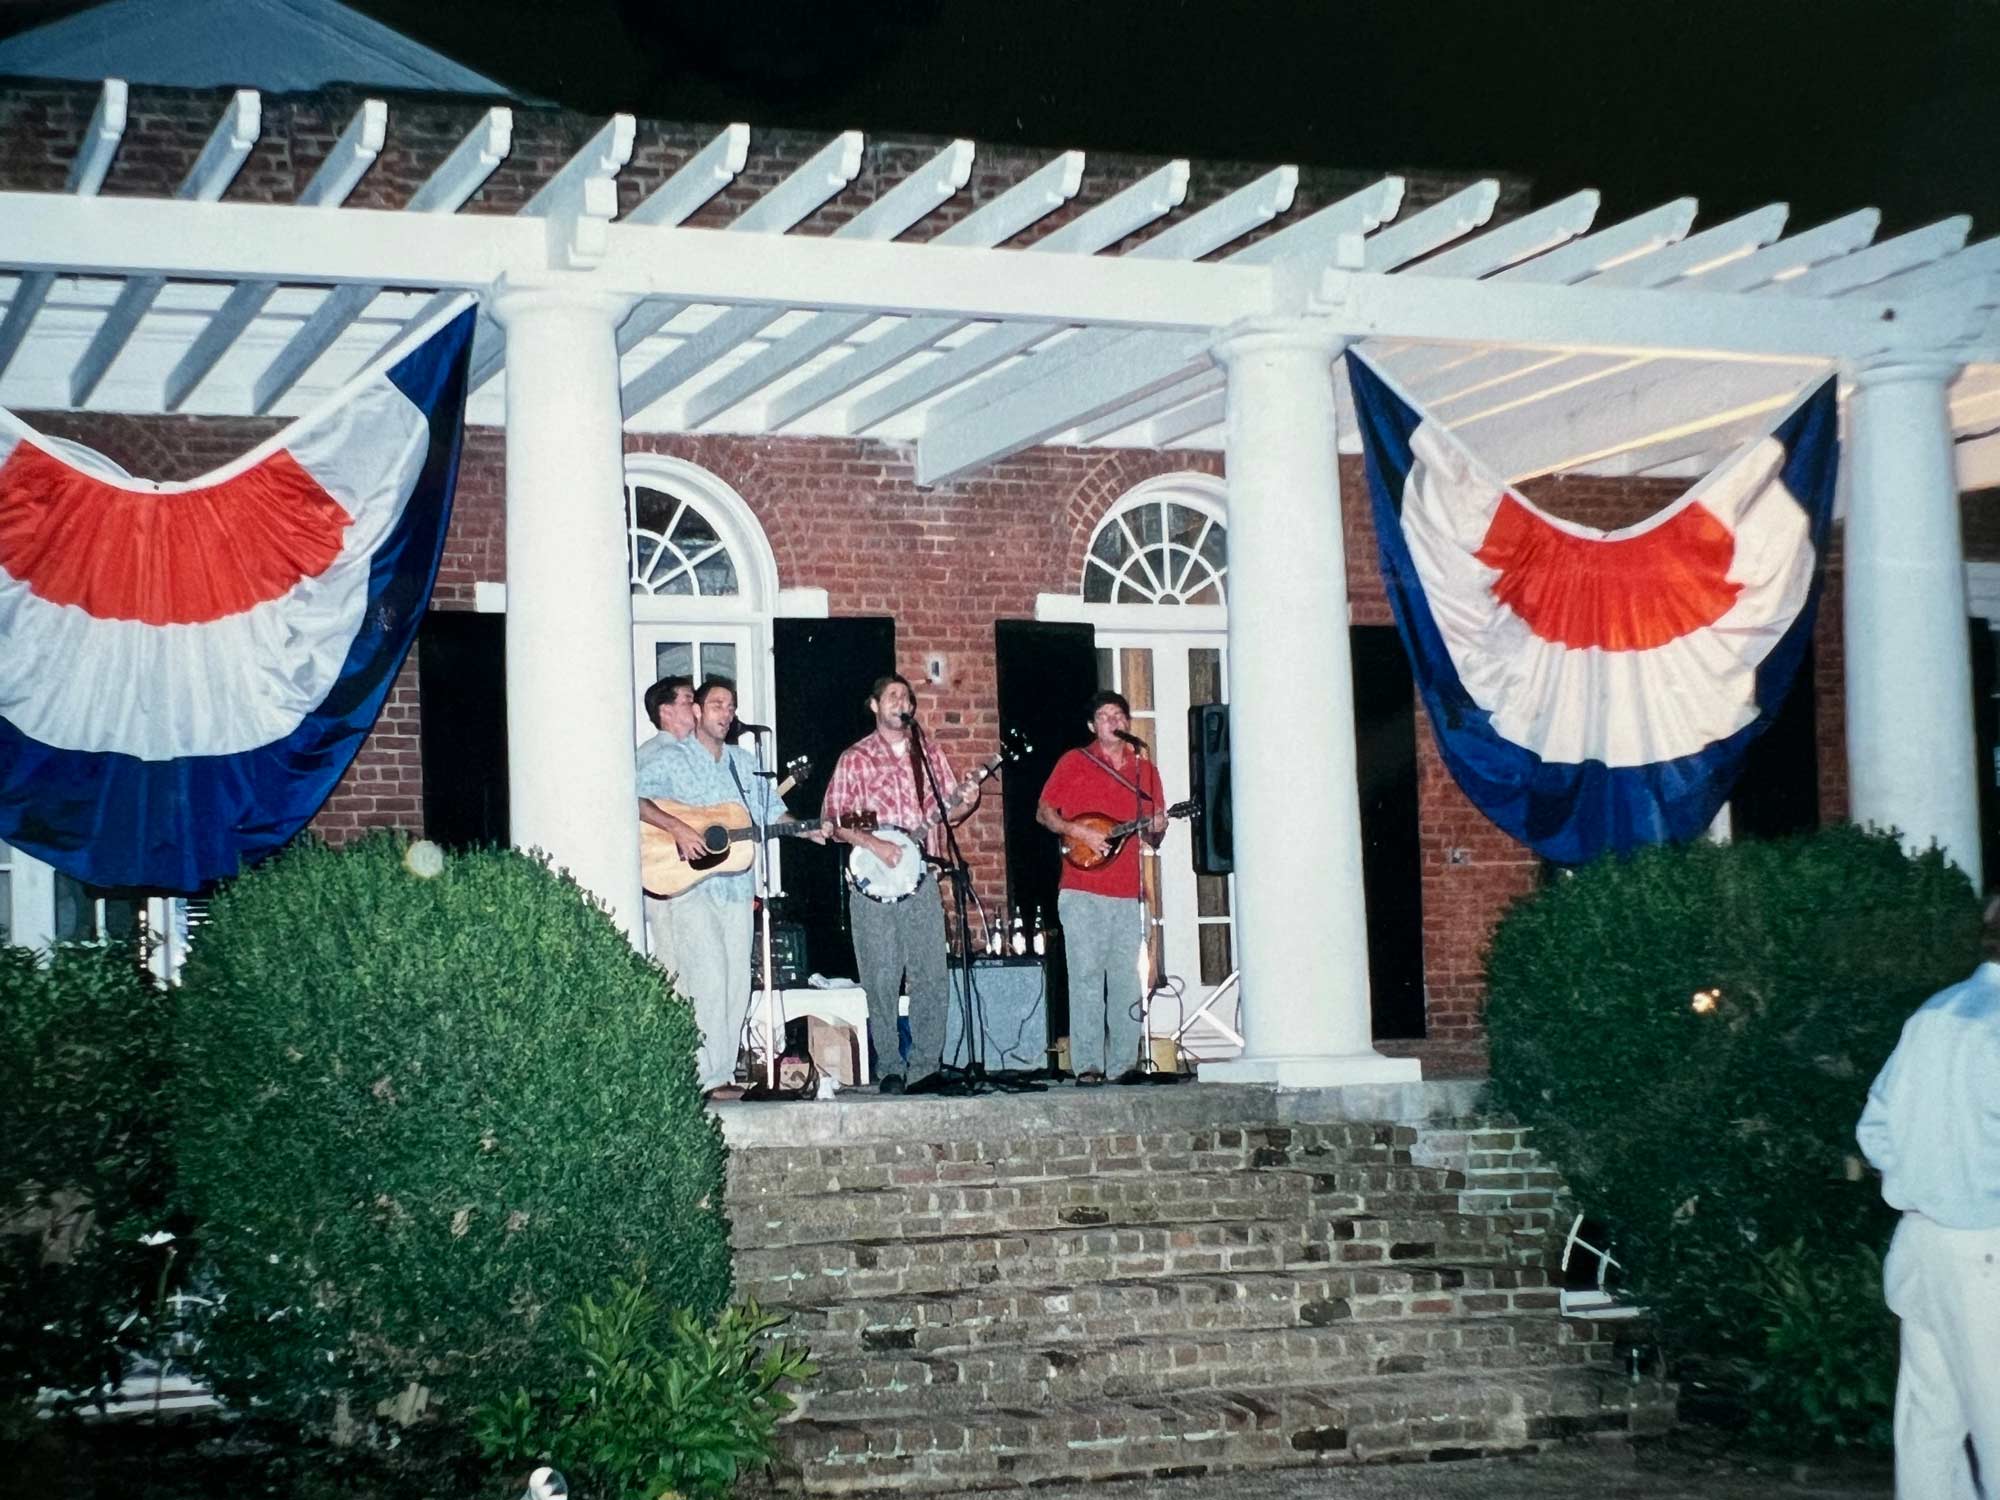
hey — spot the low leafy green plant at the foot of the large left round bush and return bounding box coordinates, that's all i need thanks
[472,1282,816,1500]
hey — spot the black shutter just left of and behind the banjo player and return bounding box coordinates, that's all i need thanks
[772,616,896,978]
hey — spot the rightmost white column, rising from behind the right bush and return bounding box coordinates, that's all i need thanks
[1840,358,1980,884]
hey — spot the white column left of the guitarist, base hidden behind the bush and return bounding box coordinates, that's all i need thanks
[490,288,644,946]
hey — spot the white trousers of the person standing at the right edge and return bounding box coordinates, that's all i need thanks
[1882,1214,2000,1500]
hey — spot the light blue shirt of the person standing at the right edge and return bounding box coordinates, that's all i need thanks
[1854,962,2000,1230]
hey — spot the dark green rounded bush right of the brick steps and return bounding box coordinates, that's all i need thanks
[1486,828,1980,1434]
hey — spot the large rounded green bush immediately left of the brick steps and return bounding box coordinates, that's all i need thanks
[174,836,730,1430]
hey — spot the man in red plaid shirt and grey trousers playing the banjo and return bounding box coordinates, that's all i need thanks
[820,672,980,1094]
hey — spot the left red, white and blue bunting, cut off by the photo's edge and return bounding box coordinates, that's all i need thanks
[0,304,474,892]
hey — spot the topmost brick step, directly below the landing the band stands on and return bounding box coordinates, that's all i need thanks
[728,1122,1416,1202]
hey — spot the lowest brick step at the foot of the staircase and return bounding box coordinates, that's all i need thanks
[780,1366,1674,1494]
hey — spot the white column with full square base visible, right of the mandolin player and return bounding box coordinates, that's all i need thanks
[1202,320,1420,1086]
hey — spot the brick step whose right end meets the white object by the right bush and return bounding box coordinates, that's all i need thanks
[774,1264,1558,1360]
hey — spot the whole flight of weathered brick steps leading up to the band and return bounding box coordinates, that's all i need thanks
[730,1090,1674,1494]
